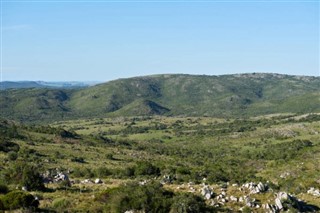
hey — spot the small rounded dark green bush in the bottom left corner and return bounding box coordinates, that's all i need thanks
[1,191,39,210]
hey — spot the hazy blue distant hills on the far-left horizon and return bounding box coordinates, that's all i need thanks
[0,81,96,90]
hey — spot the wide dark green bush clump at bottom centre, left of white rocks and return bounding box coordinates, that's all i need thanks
[96,183,214,213]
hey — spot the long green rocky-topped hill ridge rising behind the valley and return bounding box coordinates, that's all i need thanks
[0,73,320,121]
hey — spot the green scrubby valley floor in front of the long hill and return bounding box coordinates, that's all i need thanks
[0,111,320,212]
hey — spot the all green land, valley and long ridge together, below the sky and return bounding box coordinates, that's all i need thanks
[0,74,320,213]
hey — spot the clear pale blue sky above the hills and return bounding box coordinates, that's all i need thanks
[2,0,319,81]
